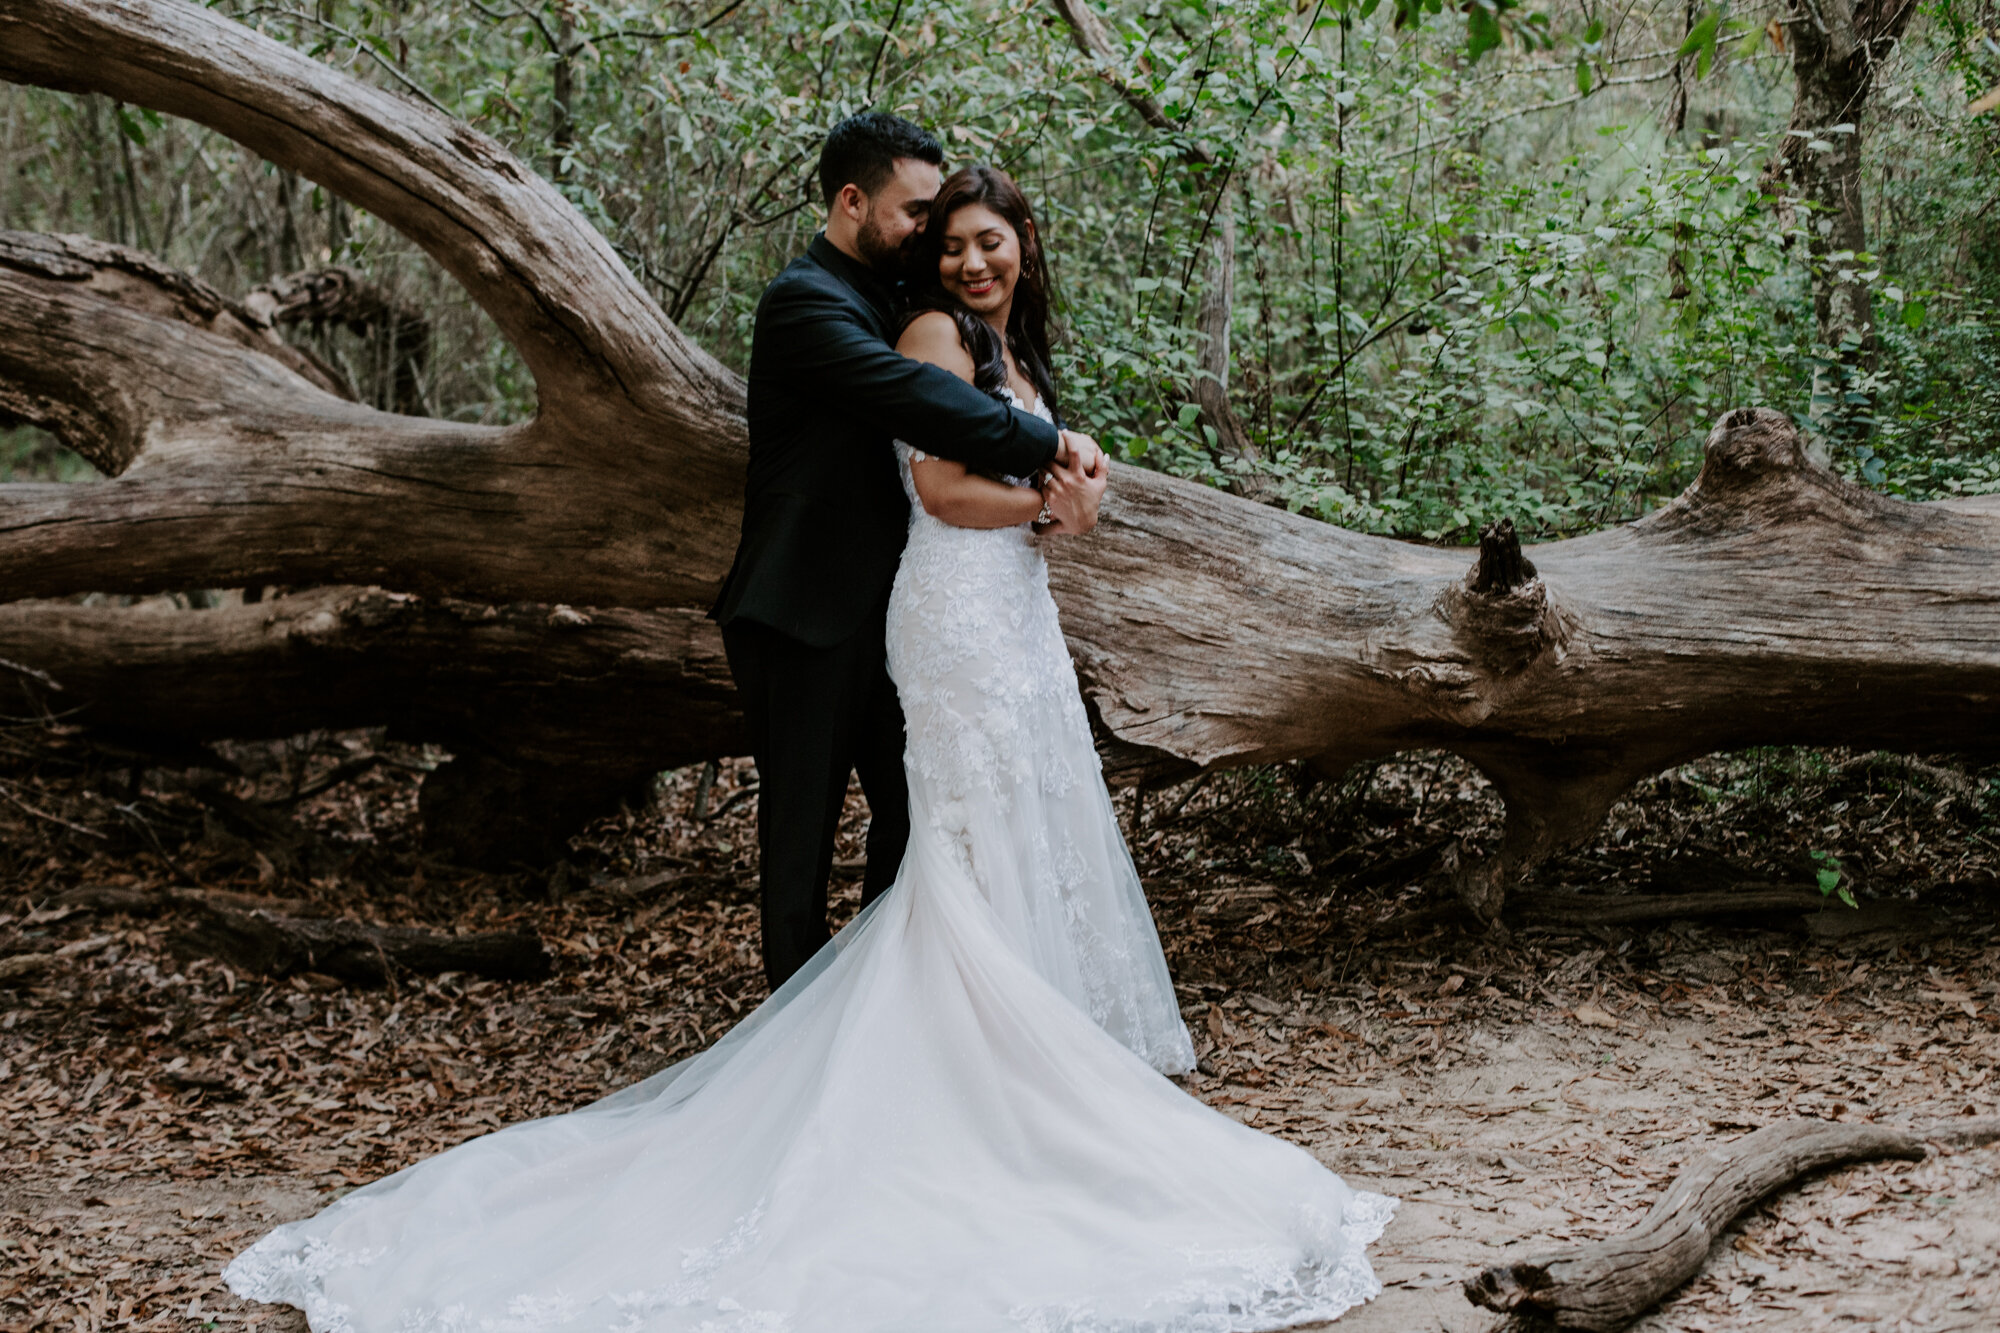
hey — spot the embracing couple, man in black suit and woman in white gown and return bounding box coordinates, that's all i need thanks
[226,114,1392,1333]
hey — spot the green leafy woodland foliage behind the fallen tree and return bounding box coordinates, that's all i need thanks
[0,0,2000,542]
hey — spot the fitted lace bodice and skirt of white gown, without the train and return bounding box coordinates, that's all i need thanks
[888,390,1194,1073]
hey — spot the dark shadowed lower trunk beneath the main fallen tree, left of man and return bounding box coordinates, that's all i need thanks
[0,588,742,867]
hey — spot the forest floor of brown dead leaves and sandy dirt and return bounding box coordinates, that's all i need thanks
[0,727,2000,1333]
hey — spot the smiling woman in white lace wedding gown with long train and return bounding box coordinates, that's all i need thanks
[224,166,1394,1333]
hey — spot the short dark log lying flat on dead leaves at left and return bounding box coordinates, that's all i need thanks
[168,905,548,987]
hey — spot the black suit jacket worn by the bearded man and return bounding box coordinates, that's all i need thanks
[710,234,1058,646]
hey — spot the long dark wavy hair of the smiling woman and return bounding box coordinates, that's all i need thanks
[910,166,1062,422]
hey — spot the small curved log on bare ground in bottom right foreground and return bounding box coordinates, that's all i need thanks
[1464,1121,1924,1333]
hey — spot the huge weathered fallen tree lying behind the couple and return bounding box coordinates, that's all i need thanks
[0,0,2000,904]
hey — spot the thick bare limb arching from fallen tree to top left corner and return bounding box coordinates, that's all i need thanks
[0,0,734,420]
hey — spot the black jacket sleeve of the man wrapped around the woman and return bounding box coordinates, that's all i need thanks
[758,286,1060,476]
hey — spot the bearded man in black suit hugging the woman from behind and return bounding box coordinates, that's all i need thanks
[710,112,1102,989]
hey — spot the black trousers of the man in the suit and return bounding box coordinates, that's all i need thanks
[722,612,910,989]
